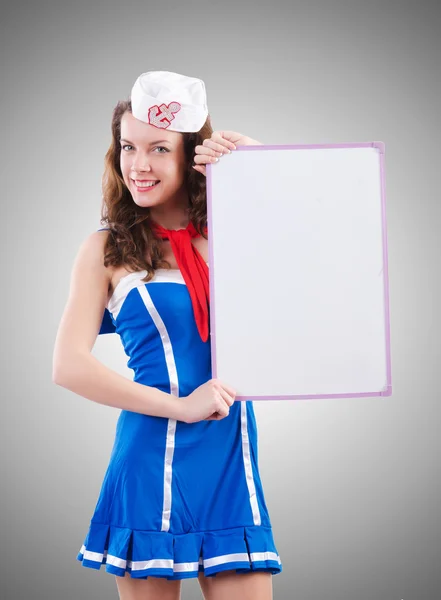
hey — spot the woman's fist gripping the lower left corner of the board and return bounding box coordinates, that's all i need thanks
[181,379,236,423]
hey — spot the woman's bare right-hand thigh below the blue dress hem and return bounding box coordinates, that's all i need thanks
[198,570,273,600]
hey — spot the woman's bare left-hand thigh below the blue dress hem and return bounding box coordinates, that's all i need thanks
[115,573,182,600]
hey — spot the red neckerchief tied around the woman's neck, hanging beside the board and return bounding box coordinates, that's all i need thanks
[150,219,210,342]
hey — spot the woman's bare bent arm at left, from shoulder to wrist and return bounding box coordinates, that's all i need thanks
[52,231,183,420]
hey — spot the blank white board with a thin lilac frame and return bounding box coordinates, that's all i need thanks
[207,142,392,400]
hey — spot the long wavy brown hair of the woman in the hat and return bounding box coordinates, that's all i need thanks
[100,100,213,282]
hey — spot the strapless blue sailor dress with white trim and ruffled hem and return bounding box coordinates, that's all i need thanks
[77,227,282,580]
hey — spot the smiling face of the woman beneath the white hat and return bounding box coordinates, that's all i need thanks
[120,112,185,207]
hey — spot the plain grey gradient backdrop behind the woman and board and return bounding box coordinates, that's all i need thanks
[0,0,441,600]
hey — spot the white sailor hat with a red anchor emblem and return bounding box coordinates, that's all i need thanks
[130,71,208,132]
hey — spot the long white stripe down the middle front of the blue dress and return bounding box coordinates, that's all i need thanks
[137,285,179,531]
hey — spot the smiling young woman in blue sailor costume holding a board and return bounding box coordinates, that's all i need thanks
[54,71,282,600]
